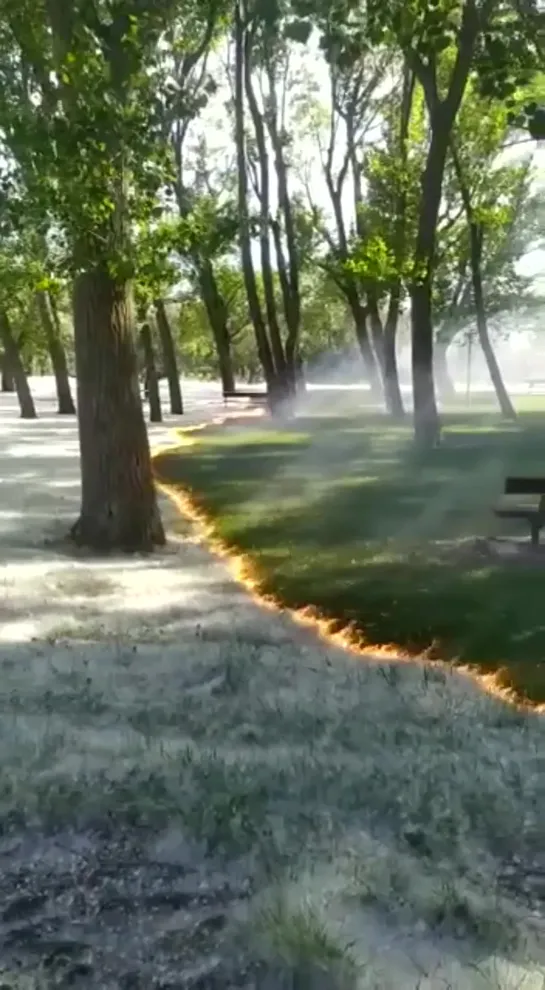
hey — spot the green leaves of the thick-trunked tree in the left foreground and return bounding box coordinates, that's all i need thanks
[0,0,223,275]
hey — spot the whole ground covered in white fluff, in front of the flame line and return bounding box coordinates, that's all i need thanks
[0,380,545,990]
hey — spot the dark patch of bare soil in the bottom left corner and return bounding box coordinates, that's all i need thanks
[0,830,255,990]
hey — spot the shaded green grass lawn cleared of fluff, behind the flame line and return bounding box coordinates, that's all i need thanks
[156,403,545,702]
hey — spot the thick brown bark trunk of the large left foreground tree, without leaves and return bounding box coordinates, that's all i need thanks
[72,268,165,552]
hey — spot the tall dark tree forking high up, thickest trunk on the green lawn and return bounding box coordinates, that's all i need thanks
[298,0,535,447]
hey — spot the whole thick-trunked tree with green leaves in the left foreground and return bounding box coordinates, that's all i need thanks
[0,0,230,549]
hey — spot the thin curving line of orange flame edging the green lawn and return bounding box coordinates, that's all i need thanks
[153,410,545,714]
